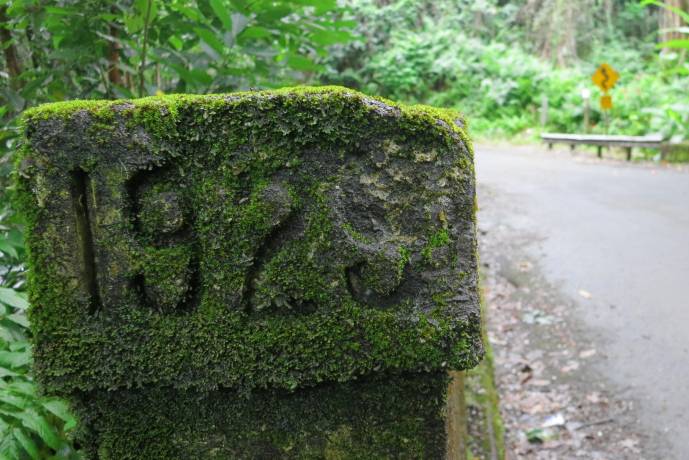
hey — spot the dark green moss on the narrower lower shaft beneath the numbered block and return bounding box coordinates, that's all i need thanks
[76,373,448,460]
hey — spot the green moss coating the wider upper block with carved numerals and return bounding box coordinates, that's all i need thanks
[19,83,478,392]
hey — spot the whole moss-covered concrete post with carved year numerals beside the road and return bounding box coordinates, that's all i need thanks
[17,88,482,460]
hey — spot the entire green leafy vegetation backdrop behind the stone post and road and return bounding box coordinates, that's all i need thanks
[0,0,689,460]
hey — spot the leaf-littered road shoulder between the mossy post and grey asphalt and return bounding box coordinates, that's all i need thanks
[479,188,668,460]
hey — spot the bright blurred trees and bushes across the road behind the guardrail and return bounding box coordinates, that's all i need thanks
[321,0,689,140]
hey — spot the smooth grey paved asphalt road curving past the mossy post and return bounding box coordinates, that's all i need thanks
[476,145,689,459]
